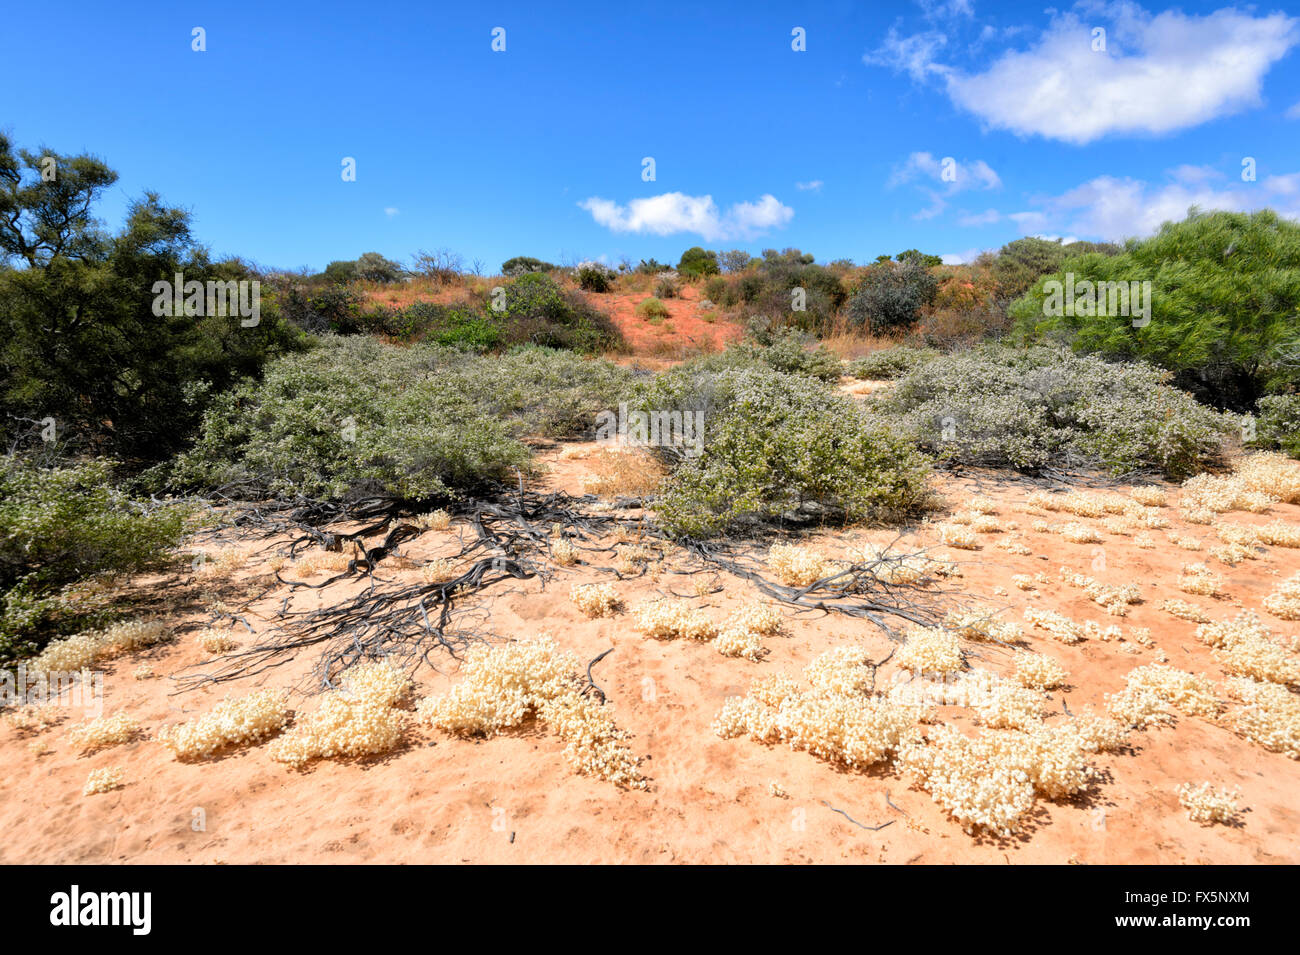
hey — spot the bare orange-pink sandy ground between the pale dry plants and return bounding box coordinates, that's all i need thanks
[0,447,1300,864]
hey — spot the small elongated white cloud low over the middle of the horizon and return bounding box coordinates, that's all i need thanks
[579,192,794,242]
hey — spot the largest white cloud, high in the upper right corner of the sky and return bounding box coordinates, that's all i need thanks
[863,3,1300,146]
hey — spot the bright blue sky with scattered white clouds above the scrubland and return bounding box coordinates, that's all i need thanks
[0,0,1300,272]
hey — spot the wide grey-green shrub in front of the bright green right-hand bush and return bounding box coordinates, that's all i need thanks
[878,346,1234,478]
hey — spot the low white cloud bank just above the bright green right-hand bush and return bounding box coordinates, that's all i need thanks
[1008,166,1300,240]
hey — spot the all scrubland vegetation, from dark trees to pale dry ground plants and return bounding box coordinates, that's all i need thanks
[0,139,1300,857]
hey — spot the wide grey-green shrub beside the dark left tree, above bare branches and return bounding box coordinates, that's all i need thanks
[170,338,639,500]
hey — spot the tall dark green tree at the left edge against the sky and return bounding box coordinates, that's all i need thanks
[0,136,304,460]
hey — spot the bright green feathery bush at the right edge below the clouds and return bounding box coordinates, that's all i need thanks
[1013,210,1300,411]
